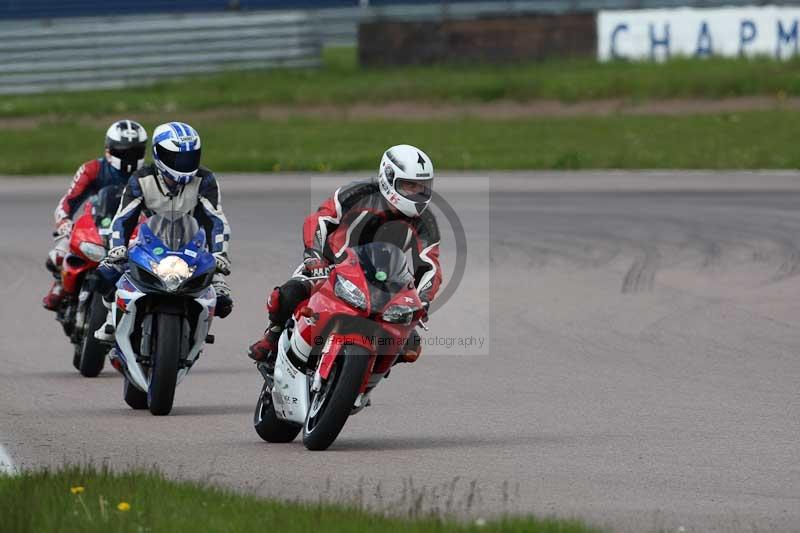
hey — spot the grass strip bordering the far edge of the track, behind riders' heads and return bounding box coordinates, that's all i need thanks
[0,111,800,175]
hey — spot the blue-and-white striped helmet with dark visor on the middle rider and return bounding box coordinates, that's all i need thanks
[153,122,200,185]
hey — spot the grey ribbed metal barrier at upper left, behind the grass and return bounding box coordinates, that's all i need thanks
[0,12,321,94]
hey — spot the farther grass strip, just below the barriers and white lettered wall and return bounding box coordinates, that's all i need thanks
[0,48,800,117]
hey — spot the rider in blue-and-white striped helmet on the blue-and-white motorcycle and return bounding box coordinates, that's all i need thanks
[95,122,233,342]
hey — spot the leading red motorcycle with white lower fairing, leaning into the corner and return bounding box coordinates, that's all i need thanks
[253,242,424,450]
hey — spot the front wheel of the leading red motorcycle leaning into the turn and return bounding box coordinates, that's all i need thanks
[303,344,371,450]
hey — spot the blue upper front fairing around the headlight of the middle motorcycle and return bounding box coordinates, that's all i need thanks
[128,219,216,290]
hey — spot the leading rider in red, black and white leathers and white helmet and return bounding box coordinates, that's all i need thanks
[248,144,442,362]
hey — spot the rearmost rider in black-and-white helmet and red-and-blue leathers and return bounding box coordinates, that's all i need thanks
[42,119,147,311]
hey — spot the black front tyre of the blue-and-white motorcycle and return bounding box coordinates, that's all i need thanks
[148,313,189,416]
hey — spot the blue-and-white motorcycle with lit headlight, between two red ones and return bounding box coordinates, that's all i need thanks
[109,213,217,415]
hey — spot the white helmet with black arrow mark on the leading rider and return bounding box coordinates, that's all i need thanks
[378,144,433,217]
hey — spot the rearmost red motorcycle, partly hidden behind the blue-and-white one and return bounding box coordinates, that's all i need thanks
[56,186,122,377]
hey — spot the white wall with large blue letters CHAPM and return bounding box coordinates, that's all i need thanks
[597,6,800,61]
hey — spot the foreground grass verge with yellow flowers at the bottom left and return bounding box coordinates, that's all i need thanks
[0,467,597,533]
